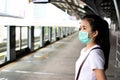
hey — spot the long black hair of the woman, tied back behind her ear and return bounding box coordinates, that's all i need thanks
[82,15,110,70]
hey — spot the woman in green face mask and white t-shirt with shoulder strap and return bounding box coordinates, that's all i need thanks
[75,15,110,80]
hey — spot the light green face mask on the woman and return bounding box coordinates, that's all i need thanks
[78,31,91,44]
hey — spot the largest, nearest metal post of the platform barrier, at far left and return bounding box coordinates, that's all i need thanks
[6,26,16,61]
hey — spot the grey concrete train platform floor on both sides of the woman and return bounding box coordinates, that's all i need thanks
[0,32,120,80]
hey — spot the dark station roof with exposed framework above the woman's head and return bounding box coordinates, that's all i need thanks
[50,0,116,19]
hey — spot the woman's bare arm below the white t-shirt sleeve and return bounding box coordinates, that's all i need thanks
[93,69,107,80]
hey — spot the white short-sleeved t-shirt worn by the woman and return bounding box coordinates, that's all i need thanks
[75,45,105,80]
